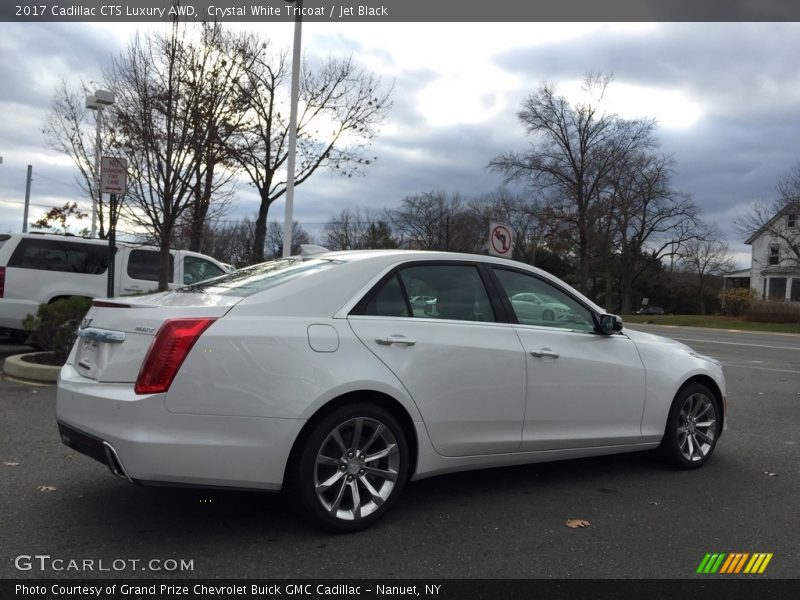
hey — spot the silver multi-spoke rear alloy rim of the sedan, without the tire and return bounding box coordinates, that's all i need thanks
[314,417,400,521]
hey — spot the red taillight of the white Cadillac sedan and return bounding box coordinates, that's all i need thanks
[134,319,216,394]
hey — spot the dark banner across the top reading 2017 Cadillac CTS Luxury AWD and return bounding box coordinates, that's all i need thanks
[0,0,800,23]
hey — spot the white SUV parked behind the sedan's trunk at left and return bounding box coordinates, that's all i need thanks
[0,233,231,340]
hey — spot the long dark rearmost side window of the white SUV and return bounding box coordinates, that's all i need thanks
[8,238,108,275]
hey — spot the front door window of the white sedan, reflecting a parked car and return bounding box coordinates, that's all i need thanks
[494,268,594,332]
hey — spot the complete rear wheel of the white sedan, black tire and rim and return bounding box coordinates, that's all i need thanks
[291,403,409,533]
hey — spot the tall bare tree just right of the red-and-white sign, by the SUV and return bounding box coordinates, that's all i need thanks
[107,21,247,290]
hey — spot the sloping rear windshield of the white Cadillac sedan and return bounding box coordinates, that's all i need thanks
[177,258,341,297]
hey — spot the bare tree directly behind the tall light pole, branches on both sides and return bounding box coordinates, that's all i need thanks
[233,36,391,262]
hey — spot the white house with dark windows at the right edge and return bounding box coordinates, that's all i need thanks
[744,205,800,302]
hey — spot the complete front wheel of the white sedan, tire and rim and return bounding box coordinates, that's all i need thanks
[659,383,722,469]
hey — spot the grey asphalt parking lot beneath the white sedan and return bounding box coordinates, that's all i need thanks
[0,325,800,579]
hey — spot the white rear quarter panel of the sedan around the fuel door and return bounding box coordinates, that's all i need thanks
[166,314,421,421]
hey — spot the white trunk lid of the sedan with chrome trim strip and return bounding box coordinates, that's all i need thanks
[67,292,242,383]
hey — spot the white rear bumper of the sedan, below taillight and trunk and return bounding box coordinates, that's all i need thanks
[56,365,305,490]
